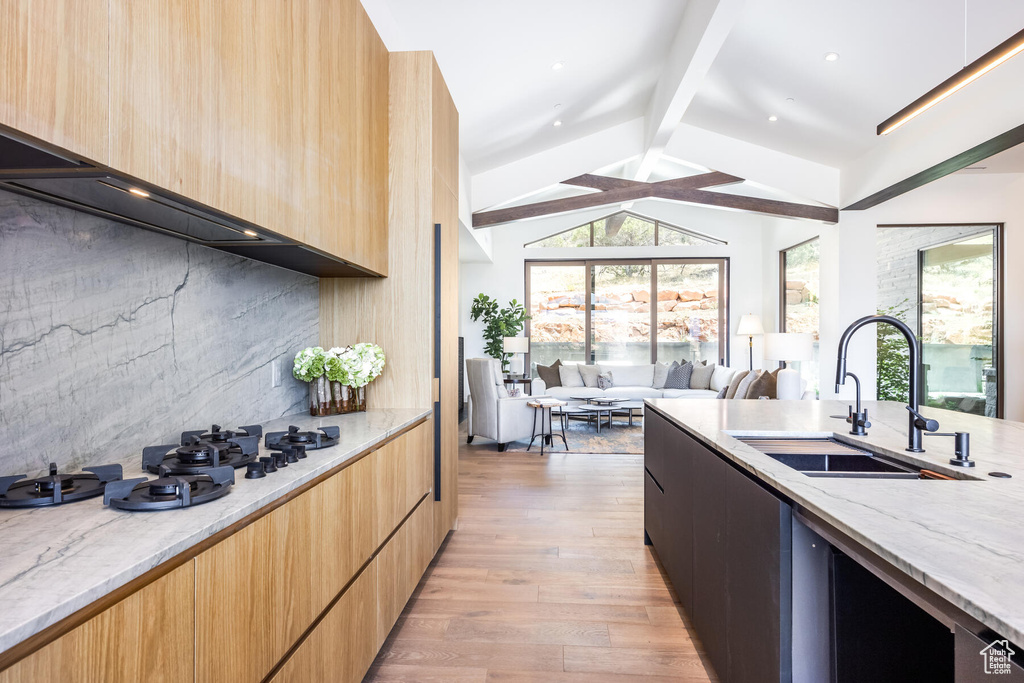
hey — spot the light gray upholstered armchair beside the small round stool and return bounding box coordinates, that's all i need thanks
[466,358,536,452]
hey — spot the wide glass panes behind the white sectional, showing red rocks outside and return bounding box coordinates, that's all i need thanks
[525,259,729,367]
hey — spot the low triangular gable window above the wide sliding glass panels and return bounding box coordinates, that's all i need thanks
[525,211,727,249]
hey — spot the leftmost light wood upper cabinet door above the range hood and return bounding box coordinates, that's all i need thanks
[0,0,110,164]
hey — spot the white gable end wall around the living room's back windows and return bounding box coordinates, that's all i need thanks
[459,200,817,395]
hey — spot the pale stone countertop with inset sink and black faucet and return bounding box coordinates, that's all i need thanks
[647,398,1024,644]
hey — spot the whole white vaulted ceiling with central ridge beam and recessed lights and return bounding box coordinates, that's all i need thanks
[362,0,1024,220]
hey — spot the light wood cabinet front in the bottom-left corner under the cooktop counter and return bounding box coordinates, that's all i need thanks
[0,561,196,683]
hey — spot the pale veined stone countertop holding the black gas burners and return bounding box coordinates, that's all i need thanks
[0,410,430,652]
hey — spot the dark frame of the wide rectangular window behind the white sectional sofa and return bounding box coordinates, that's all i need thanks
[523,256,732,369]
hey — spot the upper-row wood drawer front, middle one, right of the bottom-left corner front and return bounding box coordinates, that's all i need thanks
[196,452,376,683]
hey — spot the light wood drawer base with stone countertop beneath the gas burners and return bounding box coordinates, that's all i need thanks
[0,410,436,682]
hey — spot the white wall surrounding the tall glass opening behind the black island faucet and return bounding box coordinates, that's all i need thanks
[794,174,1024,420]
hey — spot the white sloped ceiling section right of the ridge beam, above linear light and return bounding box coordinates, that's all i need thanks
[683,0,1024,167]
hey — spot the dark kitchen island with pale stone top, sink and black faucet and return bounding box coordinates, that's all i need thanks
[645,399,1024,681]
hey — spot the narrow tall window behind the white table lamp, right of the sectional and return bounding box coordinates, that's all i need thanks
[779,238,820,393]
